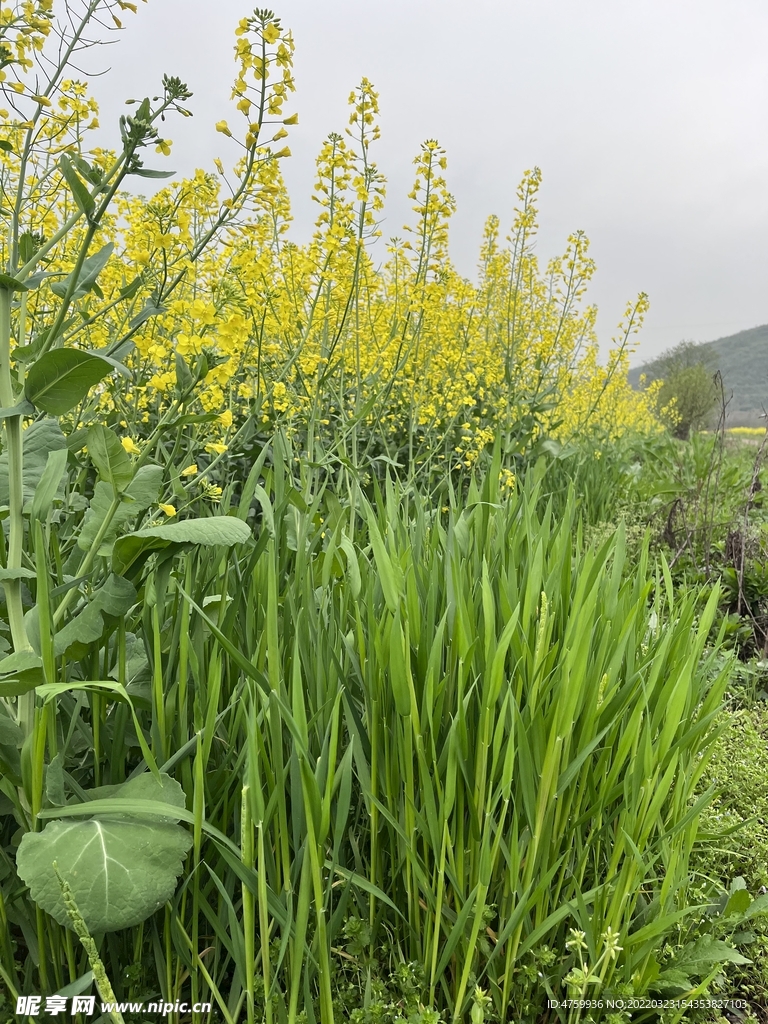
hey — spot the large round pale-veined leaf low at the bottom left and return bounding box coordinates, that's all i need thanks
[16,775,193,933]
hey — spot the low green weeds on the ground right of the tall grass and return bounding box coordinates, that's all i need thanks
[548,418,768,1020]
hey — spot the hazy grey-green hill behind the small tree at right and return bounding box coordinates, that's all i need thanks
[629,324,768,427]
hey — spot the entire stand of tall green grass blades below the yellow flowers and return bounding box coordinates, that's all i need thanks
[4,434,724,1024]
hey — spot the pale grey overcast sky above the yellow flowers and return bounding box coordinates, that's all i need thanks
[89,0,768,362]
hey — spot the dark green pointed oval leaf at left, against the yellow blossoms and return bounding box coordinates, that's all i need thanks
[25,348,113,416]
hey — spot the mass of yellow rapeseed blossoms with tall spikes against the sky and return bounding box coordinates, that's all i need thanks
[0,11,657,475]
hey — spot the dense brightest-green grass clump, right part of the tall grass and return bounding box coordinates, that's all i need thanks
[230,452,724,1019]
